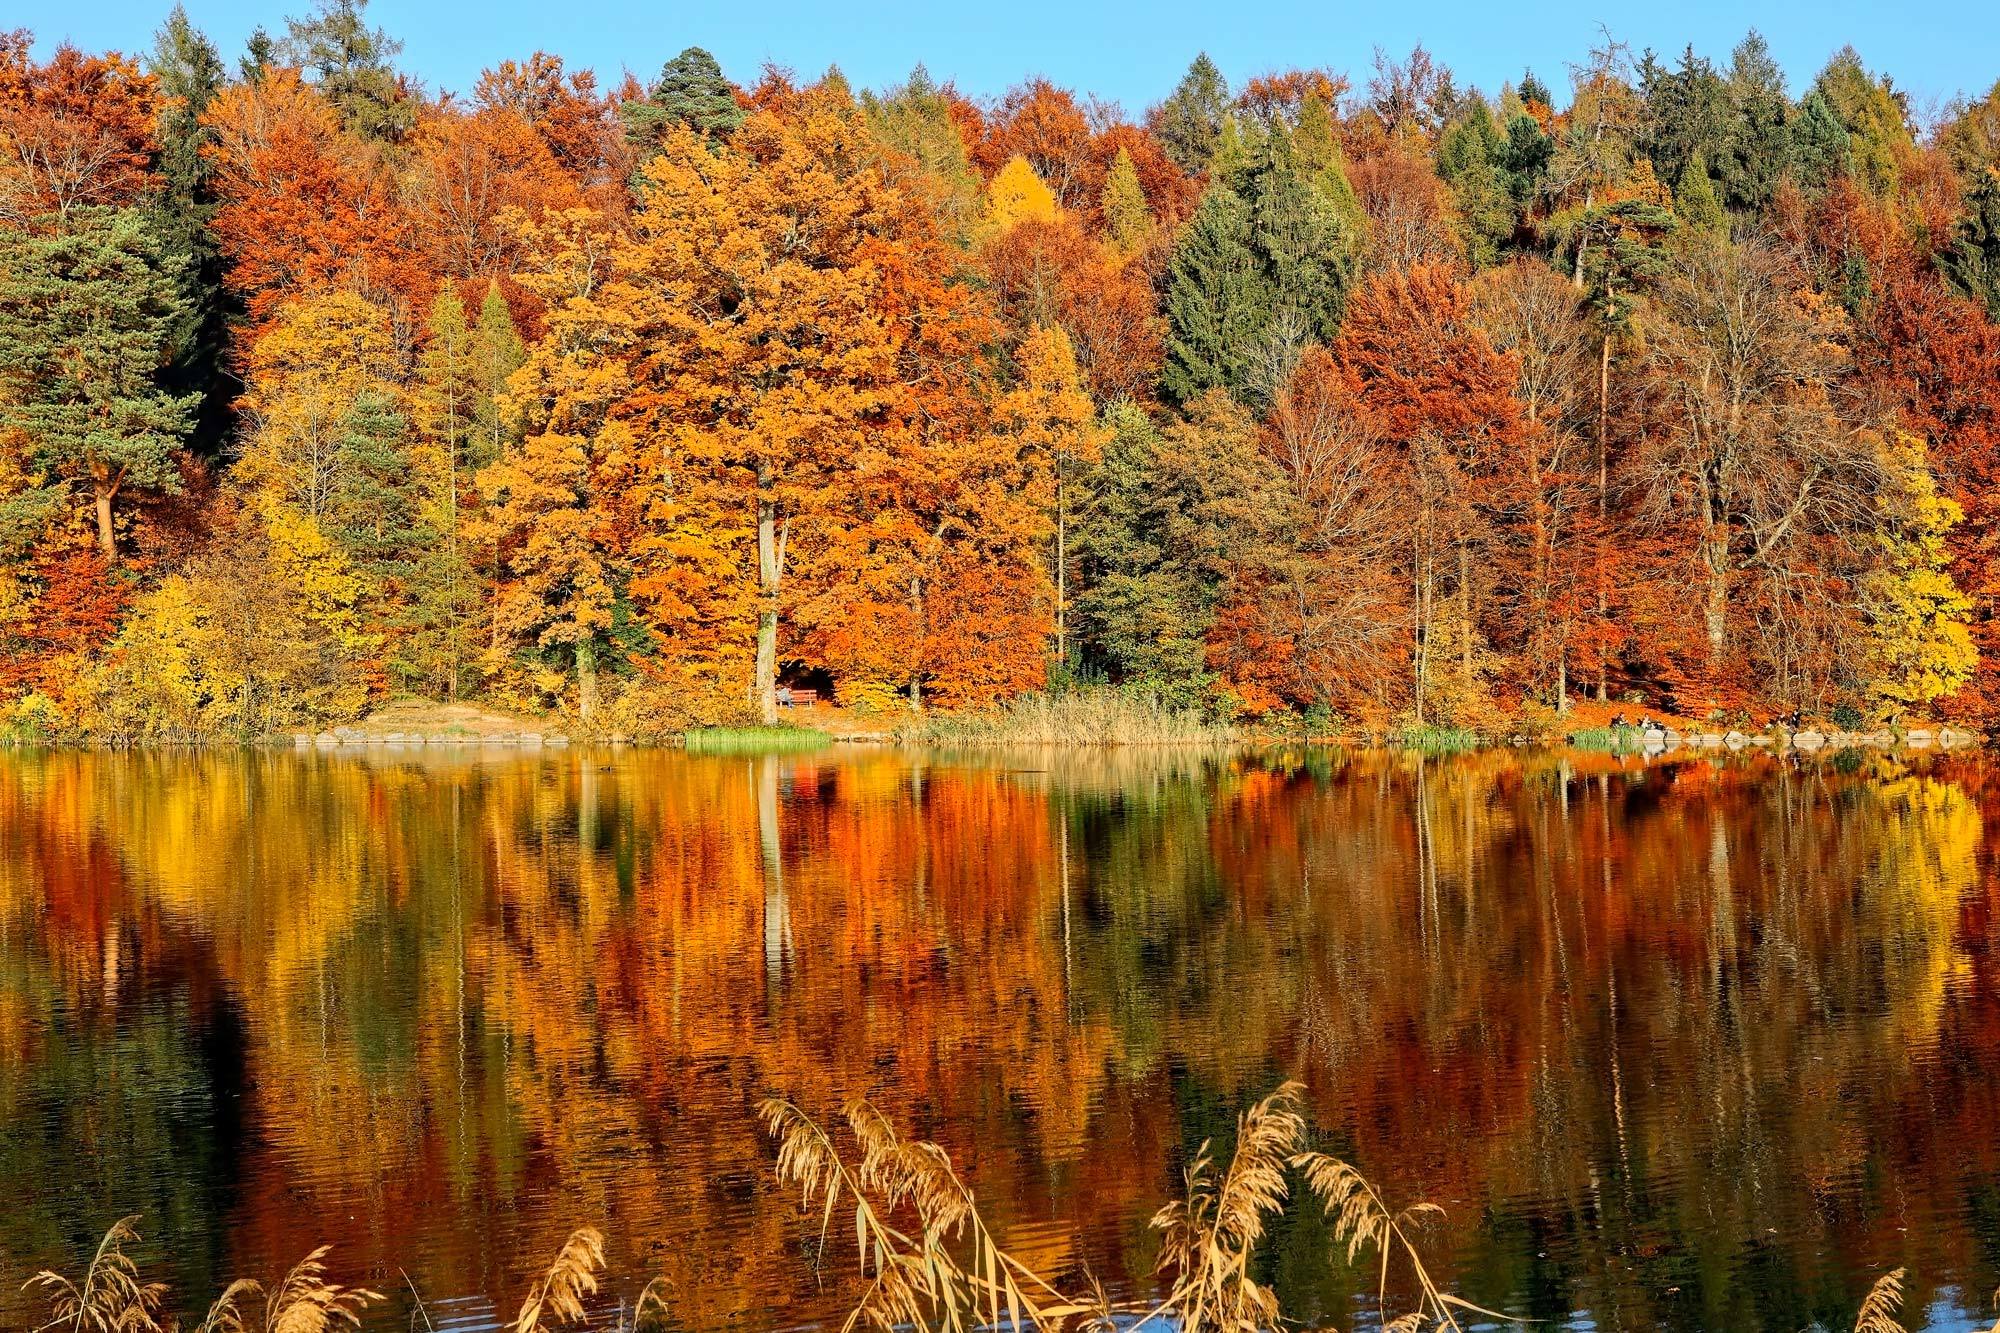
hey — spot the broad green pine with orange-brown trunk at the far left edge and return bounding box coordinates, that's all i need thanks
[0,208,196,560]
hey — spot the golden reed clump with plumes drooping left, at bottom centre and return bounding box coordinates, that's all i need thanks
[758,1097,1110,1333]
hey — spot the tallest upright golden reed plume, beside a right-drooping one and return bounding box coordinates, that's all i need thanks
[1152,1083,1306,1333]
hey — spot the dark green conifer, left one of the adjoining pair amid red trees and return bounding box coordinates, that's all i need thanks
[1160,186,1272,402]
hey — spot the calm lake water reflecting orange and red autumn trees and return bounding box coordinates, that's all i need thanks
[0,753,2000,1333]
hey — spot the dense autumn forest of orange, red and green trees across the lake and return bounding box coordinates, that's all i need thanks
[0,0,2000,741]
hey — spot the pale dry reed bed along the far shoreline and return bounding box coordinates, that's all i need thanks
[896,689,1240,749]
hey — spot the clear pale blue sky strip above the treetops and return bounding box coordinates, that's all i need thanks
[15,0,2000,116]
